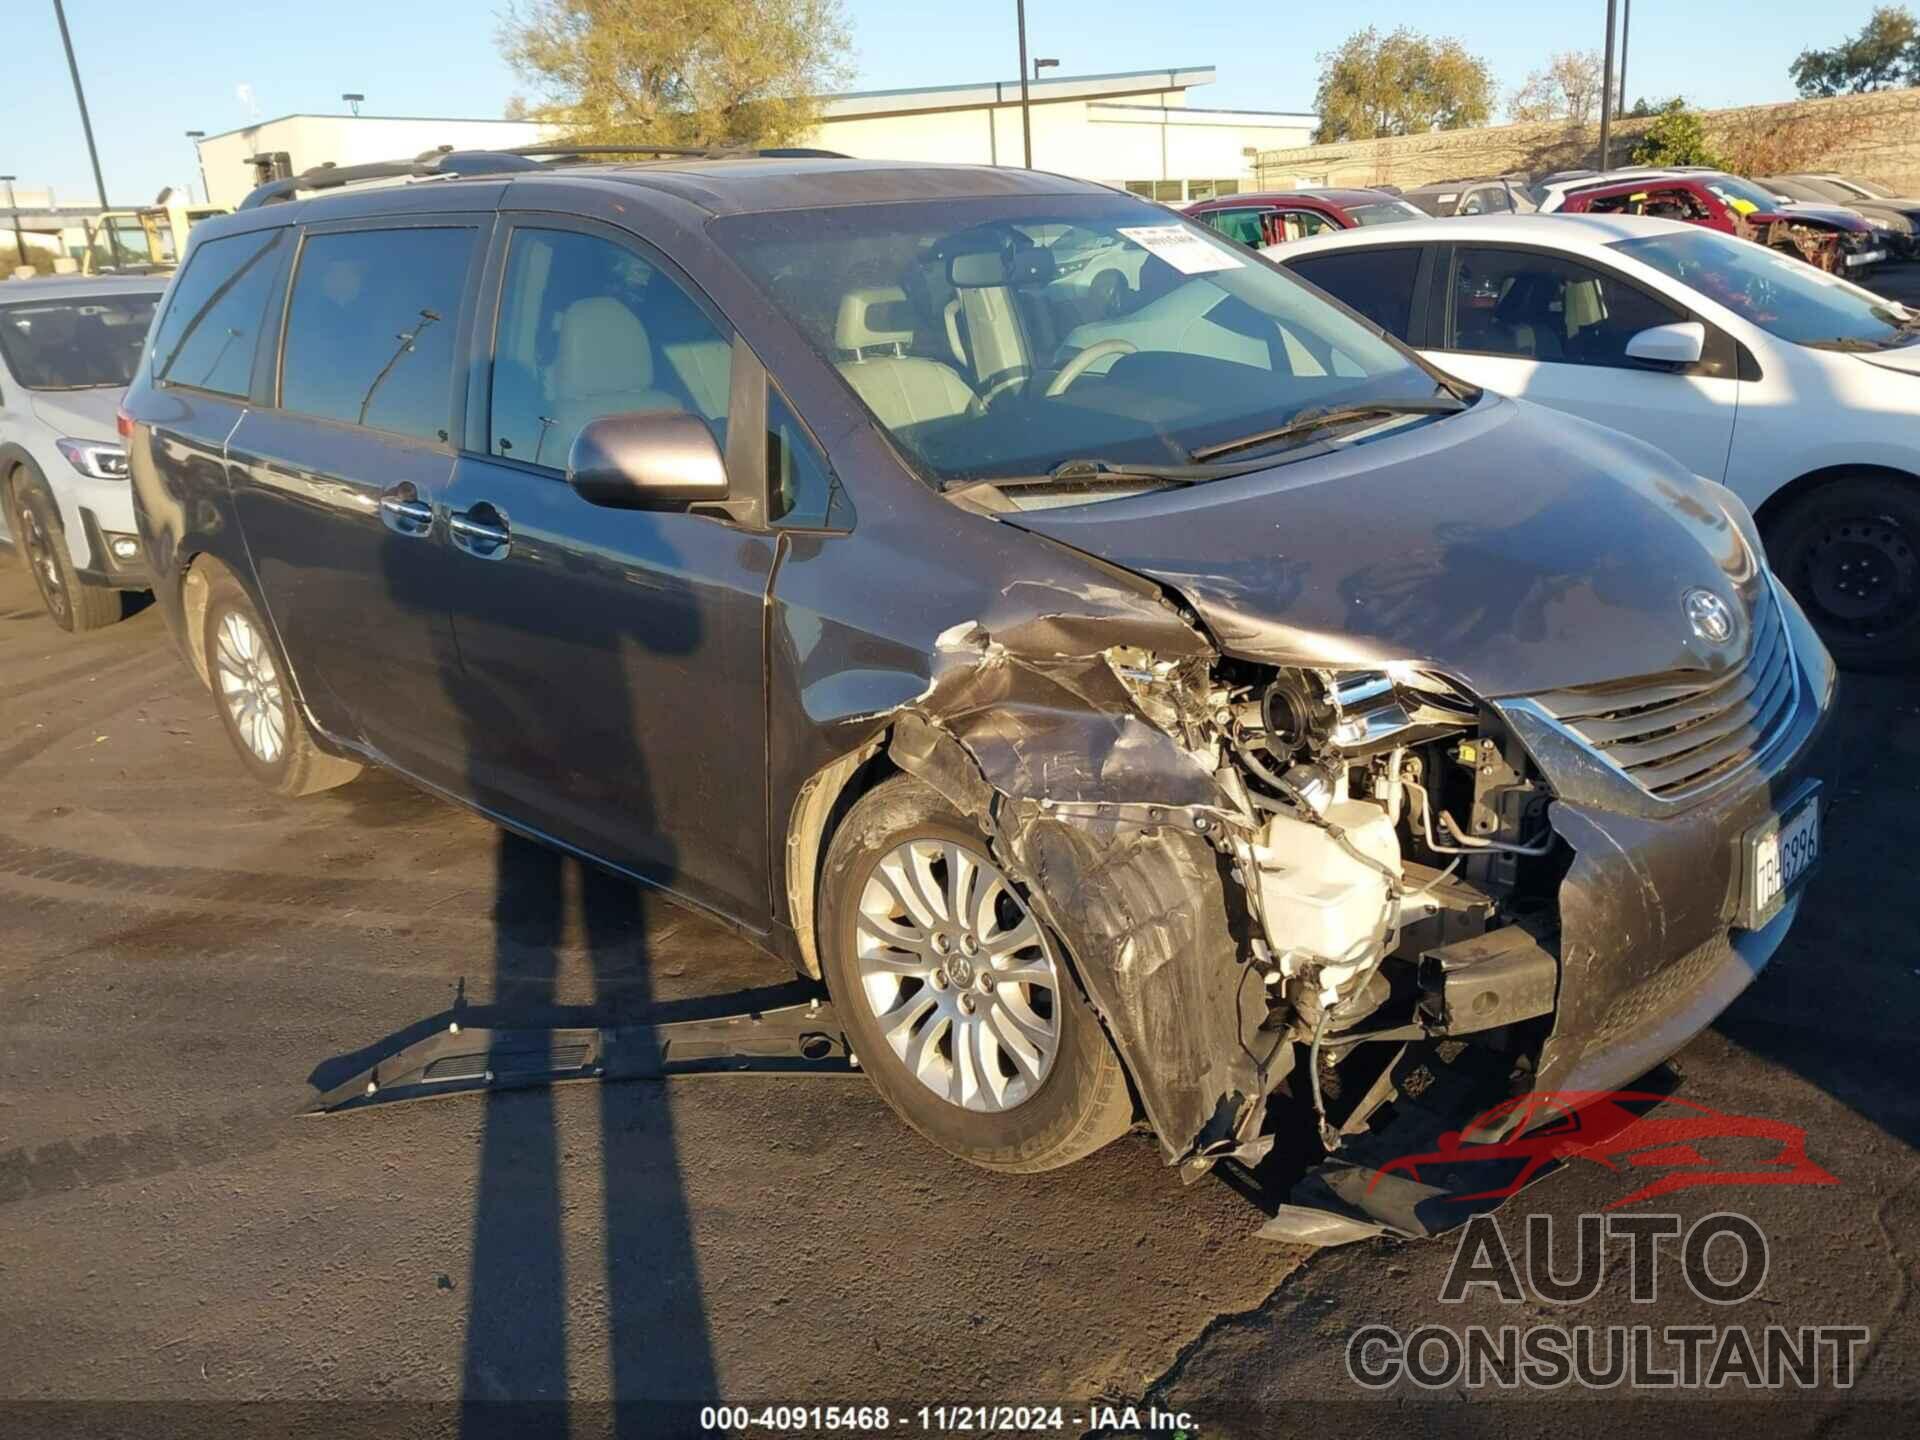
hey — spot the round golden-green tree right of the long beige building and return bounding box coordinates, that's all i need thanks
[1313,25,1494,144]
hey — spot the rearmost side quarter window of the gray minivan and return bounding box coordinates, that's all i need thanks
[152,230,286,396]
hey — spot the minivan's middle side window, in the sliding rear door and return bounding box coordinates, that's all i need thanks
[280,227,474,442]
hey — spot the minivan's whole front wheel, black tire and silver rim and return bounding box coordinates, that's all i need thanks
[820,776,1133,1171]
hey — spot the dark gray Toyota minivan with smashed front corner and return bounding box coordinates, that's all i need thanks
[123,156,1834,1221]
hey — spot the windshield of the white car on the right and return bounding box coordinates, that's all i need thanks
[1613,230,1920,349]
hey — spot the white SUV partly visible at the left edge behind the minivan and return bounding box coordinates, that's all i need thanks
[0,276,167,630]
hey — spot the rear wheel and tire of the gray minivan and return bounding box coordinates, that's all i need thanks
[202,574,361,795]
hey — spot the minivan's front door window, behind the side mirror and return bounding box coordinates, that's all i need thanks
[490,228,733,470]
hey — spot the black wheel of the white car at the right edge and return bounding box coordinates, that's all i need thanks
[1766,474,1920,670]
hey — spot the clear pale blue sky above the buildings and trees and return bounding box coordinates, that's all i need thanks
[0,0,1896,204]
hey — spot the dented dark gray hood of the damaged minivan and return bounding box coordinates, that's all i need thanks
[1000,396,1759,699]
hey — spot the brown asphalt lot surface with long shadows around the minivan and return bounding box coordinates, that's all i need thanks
[0,272,1920,1436]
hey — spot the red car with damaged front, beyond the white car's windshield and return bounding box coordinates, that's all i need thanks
[1542,171,1887,275]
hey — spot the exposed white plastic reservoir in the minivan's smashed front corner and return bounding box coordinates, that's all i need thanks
[1254,801,1402,983]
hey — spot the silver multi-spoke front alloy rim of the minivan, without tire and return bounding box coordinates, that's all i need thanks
[854,839,1062,1112]
